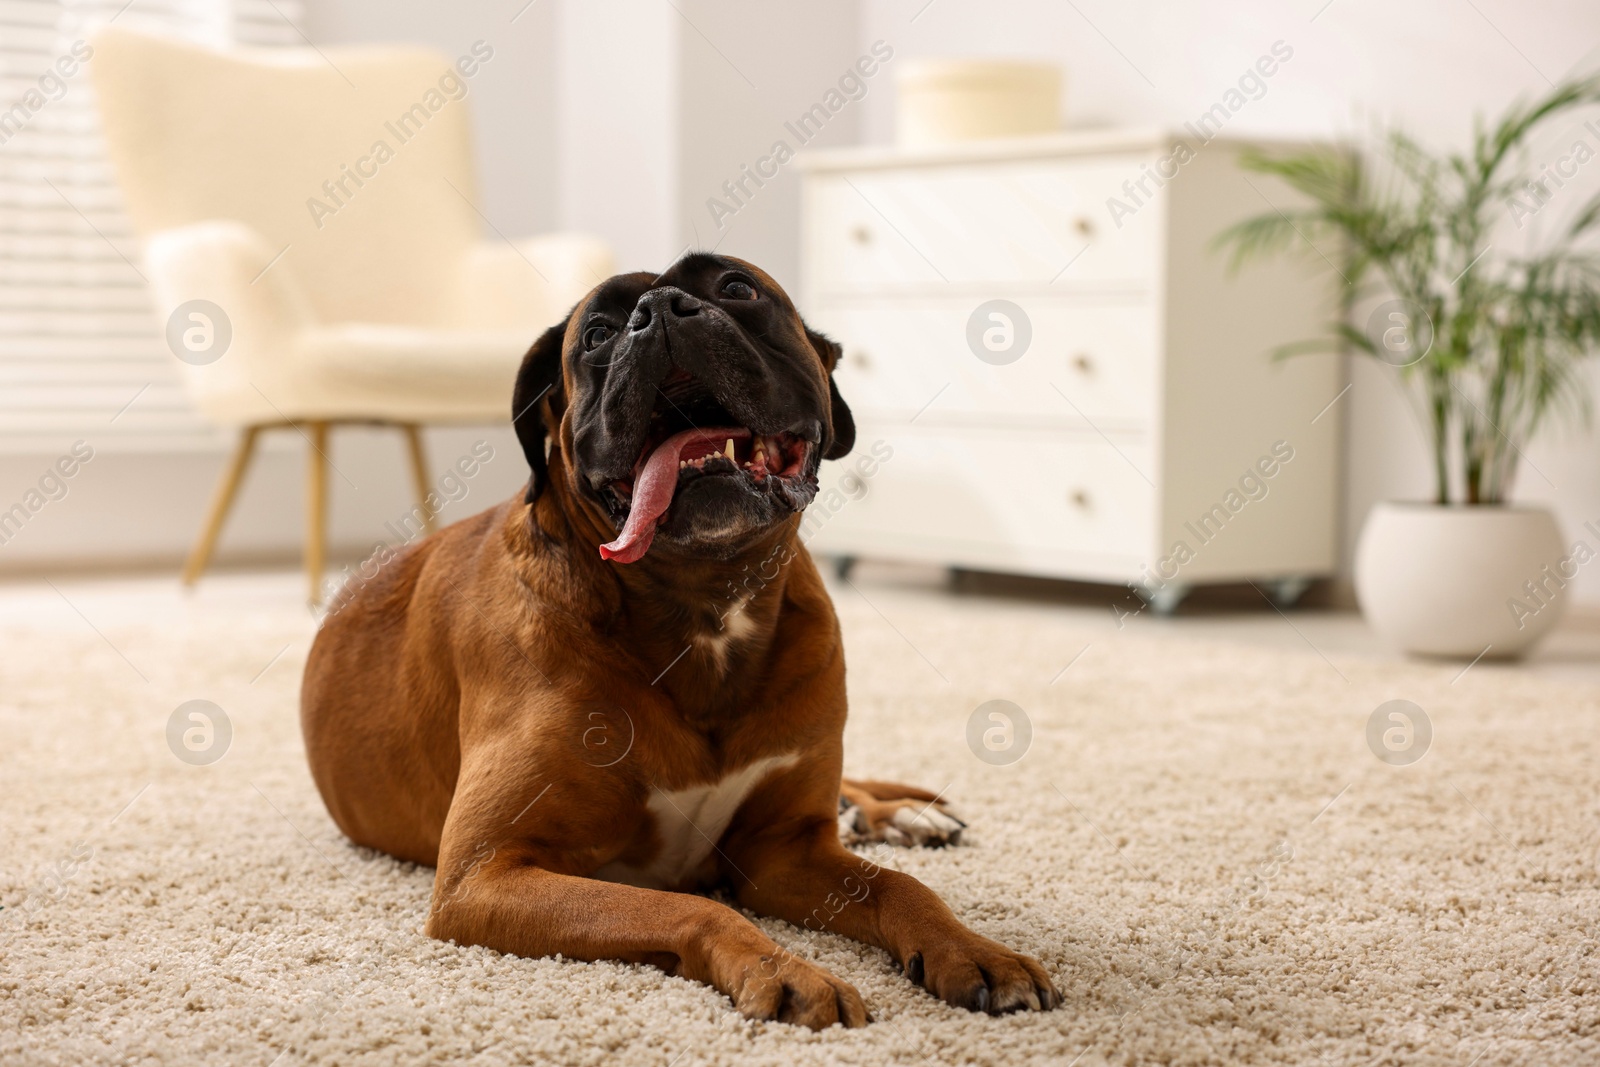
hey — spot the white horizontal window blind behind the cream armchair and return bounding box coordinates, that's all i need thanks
[0,0,304,453]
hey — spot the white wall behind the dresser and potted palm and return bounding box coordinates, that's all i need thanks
[858,0,1600,601]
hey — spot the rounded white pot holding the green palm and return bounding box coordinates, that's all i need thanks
[1355,504,1582,659]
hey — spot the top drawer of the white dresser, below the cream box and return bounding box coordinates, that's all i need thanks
[806,155,1162,294]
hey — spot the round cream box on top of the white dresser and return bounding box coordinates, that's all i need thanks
[894,59,1061,147]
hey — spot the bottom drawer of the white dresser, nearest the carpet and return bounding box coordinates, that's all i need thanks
[808,424,1157,560]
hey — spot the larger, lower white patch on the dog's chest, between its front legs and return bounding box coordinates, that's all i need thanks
[594,753,800,889]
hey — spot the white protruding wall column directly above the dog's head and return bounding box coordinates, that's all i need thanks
[558,0,888,285]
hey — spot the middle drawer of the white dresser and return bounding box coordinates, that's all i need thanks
[813,299,1158,429]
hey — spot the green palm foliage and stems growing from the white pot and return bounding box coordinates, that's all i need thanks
[1214,74,1600,502]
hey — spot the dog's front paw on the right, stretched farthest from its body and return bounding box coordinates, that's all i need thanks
[906,931,1061,1016]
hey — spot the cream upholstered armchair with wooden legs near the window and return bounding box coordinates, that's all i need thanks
[91,27,613,601]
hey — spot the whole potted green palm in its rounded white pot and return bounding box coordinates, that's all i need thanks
[1218,75,1600,657]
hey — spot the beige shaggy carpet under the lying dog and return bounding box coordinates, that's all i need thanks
[0,584,1600,1067]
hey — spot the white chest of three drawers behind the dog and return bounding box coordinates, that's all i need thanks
[802,131,1342,608]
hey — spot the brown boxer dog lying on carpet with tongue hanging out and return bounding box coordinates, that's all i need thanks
[301,254,1059,1027]
